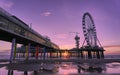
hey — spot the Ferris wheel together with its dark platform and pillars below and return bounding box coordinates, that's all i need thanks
[80,12,104,59]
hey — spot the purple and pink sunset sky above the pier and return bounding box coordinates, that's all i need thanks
[0,0,120,53]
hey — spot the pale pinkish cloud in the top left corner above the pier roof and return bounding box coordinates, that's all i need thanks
[0,0,14,10]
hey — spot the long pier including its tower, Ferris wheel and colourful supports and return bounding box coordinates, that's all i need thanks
[0,8,105,63]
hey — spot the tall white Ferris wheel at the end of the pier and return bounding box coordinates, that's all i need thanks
[82,12,97,47]
